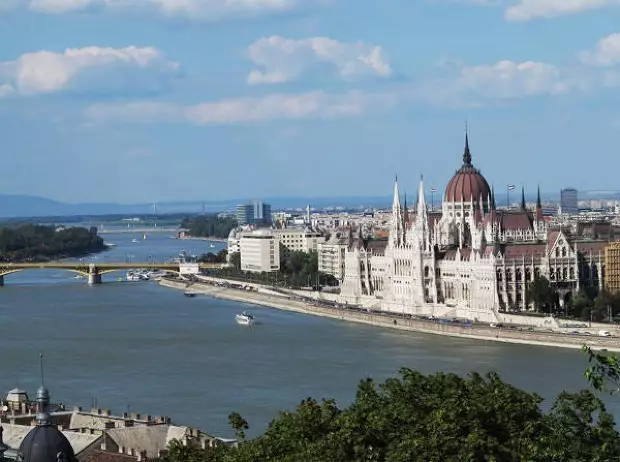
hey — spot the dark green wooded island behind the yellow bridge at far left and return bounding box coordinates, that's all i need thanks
[0,224,105,262]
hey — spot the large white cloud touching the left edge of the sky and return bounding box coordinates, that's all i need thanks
[0,46,179,94]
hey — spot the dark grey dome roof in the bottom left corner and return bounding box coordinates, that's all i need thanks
[19,425,76,462]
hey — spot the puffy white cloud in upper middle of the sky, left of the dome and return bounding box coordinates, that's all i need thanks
[247,36,392,84]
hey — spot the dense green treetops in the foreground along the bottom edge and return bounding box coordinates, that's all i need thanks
[165,369,620,462]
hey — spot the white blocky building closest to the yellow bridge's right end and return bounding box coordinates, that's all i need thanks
[239,229,280,273]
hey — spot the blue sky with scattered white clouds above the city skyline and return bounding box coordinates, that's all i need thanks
[0,0,620,203]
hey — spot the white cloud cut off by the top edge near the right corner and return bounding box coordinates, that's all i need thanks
[506,0,620,21]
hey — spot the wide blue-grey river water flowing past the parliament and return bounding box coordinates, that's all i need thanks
[0,234,620,436]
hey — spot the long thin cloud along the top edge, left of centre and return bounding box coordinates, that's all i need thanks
[23,0,298,20]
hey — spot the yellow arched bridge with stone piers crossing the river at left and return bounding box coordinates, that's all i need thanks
[0,261,226,286]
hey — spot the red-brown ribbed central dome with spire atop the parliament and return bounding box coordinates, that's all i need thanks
[444,134,491,203]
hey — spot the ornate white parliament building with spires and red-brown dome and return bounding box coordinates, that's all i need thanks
[341,135,614,322]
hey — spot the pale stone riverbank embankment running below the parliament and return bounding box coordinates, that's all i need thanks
[159,279,620,352]
